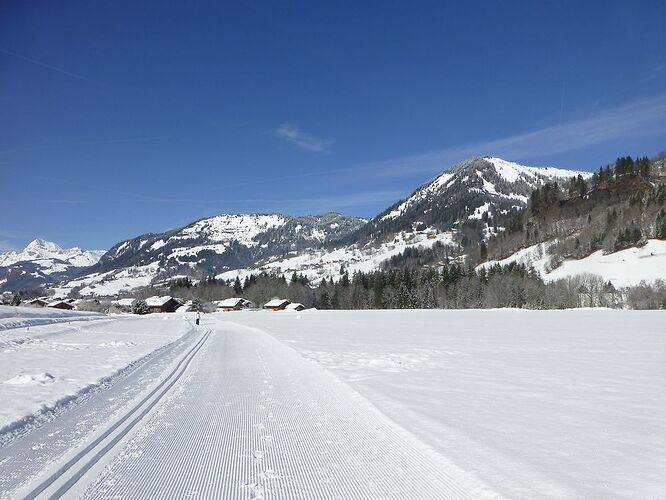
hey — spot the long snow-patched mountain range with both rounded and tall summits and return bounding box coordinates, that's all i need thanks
[49,157,589,295]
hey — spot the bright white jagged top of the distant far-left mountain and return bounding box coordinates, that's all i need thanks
[0,238,104,272]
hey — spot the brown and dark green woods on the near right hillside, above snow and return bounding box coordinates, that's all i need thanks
[479,156,666,268]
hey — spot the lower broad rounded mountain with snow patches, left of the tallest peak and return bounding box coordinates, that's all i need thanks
[53,213,367,295]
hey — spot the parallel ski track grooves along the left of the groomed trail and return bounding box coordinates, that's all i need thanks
[24,330,211,500]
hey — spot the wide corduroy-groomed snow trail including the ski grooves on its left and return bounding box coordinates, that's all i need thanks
[31,322,477,499]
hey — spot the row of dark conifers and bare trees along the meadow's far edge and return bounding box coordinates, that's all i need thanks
[139,264,623,310]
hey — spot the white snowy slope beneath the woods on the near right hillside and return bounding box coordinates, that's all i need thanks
[479,240,666,288]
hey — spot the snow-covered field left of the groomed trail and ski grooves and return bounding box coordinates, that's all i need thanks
[0,306,190,431]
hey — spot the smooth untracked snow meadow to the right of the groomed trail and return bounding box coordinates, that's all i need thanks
[227,310,666,499]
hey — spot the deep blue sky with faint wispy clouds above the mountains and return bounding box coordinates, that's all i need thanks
[0,0,666,249]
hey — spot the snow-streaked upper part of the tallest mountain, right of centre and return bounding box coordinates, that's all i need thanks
[376,156,592,221]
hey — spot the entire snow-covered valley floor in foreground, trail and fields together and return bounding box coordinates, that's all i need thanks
[0,310,666,499]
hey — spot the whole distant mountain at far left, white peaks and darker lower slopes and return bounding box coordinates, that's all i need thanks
[0,239,104,291]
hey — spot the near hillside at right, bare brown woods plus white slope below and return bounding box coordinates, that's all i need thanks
[482,157,666,288]
